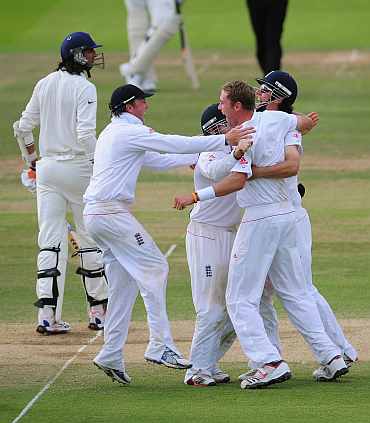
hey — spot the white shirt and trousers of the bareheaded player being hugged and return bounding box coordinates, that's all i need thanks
[226,111,340,363]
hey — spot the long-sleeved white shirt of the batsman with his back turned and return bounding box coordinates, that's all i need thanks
[19,70,97,159]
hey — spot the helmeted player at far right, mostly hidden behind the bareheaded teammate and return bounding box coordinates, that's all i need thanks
[241,71,357,381]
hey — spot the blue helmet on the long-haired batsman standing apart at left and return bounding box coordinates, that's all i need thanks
[60,32,102,65]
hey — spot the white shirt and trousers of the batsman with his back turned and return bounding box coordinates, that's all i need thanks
[19,70,107,323]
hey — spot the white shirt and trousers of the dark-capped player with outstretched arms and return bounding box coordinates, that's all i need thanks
[84,113,225,370]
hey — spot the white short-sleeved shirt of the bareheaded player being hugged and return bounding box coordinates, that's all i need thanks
[232,111,300,208]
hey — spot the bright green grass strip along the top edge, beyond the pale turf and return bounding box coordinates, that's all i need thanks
[0,0,370,55]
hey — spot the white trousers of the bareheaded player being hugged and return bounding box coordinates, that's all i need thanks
[226,212,340,364]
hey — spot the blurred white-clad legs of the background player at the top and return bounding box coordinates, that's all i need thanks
[119,0,181,93]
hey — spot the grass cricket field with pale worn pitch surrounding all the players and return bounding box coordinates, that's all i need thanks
[0,0,370,423]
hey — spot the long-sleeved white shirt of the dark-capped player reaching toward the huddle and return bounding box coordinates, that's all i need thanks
[84,113,225,204]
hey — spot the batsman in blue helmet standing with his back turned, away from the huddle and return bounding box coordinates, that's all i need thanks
[13,32,107,334]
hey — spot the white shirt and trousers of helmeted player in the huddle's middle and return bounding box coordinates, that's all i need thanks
[185,147,241,382]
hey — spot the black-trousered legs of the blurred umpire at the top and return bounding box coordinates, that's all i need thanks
[246,0,288,74]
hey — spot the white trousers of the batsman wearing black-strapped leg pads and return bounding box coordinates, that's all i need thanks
[36,157,108,321]
